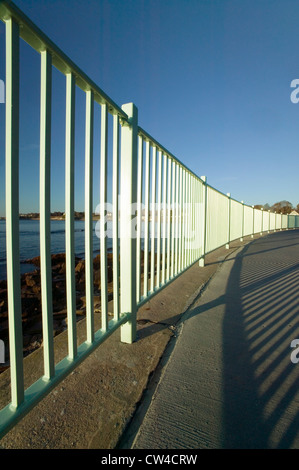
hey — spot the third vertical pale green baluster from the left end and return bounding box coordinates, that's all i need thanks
[65,73,77,359]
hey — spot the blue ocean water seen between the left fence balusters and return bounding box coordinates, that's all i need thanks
[0,220,112,279]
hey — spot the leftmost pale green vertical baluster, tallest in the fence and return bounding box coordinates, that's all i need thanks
[5,18,24,407]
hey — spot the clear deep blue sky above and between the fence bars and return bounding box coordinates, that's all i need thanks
[0,0,299,215]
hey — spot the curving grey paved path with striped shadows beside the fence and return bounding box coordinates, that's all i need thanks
[133,230,299,449]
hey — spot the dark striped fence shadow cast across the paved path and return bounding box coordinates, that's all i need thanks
[223,232,299,449]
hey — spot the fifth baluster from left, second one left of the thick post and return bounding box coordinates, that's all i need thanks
[100,103,108,331]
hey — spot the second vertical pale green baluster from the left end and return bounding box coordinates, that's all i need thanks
[40,50,54,379]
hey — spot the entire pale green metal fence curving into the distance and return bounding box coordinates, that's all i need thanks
[0,1,299,436]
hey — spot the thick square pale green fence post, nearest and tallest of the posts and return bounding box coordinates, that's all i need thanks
[120,103,138,343]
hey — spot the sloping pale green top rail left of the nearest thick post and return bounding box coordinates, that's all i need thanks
[0,0,128,121]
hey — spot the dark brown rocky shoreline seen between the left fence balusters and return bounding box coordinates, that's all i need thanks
[0,253,113,373]
